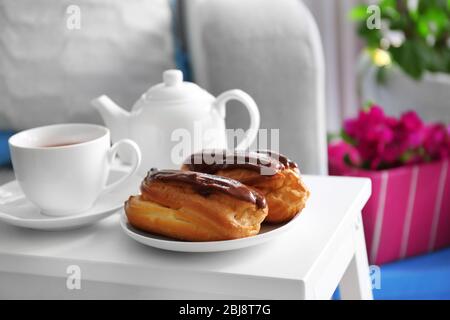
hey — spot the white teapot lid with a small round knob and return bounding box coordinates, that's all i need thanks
[141,69,213,103]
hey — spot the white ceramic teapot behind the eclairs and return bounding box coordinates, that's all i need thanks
[92,70,260,175]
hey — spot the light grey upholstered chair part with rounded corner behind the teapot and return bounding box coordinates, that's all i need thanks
[181,0,327,174]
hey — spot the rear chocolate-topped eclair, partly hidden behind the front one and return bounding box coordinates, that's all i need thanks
[181,150,310,223]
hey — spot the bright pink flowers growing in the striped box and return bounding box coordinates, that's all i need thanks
[329,105,450,170]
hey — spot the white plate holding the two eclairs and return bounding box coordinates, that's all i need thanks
[120,210,301,252]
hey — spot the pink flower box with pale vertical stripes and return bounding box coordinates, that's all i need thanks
[330,159,450,264]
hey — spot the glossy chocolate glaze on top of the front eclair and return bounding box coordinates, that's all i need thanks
[141,169,267,209]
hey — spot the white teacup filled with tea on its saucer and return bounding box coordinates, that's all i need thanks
[9,124,141,216]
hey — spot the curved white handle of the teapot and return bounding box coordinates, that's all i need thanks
[214,89,260,150]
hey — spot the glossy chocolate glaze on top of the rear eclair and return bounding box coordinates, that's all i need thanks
[184,150,297,175]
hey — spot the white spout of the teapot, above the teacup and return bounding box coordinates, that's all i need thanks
[91,95,130,142]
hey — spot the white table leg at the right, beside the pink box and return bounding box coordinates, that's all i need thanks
[339,214,373,300]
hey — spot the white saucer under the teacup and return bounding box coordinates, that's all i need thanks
[0,170,142,230]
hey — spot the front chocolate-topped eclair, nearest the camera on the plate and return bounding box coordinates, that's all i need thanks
[125,170,268,241]
